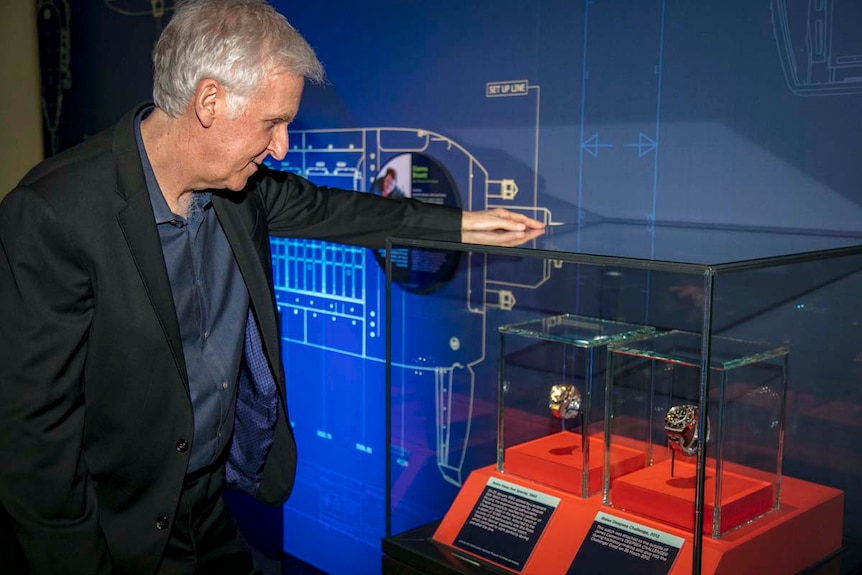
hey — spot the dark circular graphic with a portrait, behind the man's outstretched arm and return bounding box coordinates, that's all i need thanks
[371,152,461,293]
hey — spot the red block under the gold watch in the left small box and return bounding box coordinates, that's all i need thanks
[503,431,646,495]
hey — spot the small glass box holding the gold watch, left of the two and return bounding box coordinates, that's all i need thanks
[497,314,653,497]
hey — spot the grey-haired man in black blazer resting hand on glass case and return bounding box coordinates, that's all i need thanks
[0,0,542,575]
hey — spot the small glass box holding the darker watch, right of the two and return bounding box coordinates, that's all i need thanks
[603,331,788,538]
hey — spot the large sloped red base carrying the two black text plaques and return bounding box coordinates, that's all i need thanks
[433,466,844,575]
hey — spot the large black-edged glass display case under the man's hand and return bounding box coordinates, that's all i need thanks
[383,222,862,575]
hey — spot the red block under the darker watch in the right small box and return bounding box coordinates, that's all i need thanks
[612,458,775,535]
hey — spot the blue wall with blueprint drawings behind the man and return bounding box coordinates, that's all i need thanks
[40,0,862,574]
